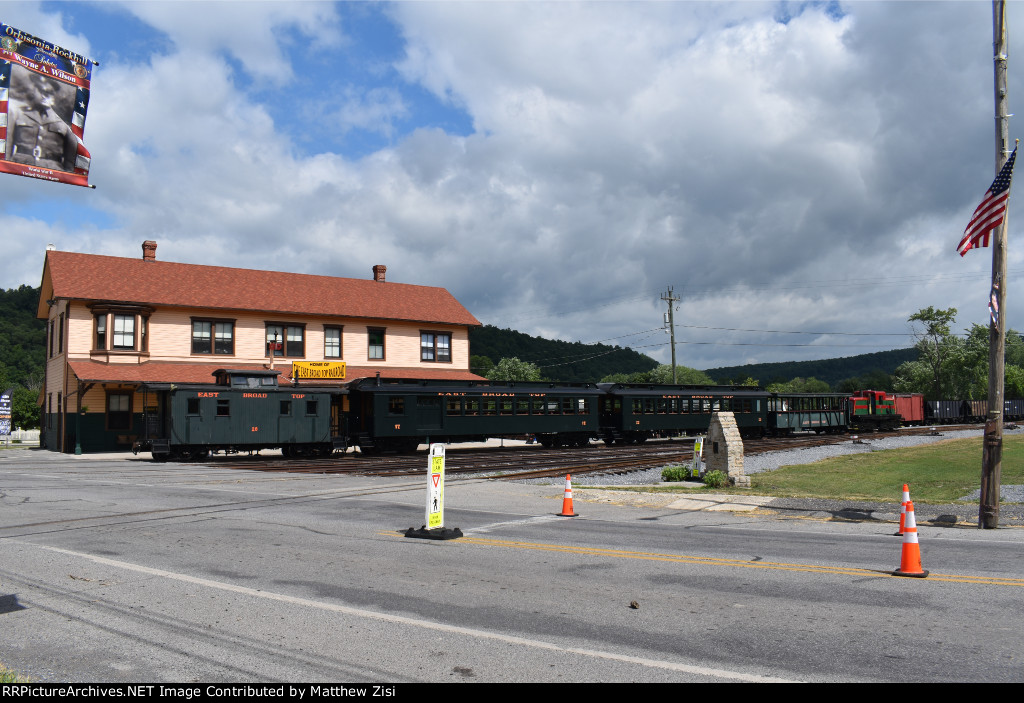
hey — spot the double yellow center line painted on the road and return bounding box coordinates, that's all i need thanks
[380,532,1024,587]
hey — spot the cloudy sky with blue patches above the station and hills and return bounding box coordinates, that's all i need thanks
[0,1,1024,368]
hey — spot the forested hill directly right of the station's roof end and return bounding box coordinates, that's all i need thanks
[469,324,657,383]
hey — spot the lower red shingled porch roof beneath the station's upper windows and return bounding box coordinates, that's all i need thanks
[68,360,483,386]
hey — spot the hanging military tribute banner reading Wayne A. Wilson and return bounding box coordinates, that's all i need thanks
[0,23,95,186]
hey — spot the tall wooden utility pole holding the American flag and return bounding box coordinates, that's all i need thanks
[978,0,1010,529]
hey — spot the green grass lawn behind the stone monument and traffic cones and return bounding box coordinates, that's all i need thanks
[622,435,1024,502]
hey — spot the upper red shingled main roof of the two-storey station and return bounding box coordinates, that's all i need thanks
[40,251,480,326]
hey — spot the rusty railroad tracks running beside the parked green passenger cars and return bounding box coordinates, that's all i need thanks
[186,425,978,480]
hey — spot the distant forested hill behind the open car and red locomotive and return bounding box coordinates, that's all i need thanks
[705,349,918,388]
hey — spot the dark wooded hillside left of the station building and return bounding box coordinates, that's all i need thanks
[0,285,46,391]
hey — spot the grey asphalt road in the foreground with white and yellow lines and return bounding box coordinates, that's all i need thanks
[0,450,1024,683]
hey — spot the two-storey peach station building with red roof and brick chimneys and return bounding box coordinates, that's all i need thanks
[37,241,481,452]
